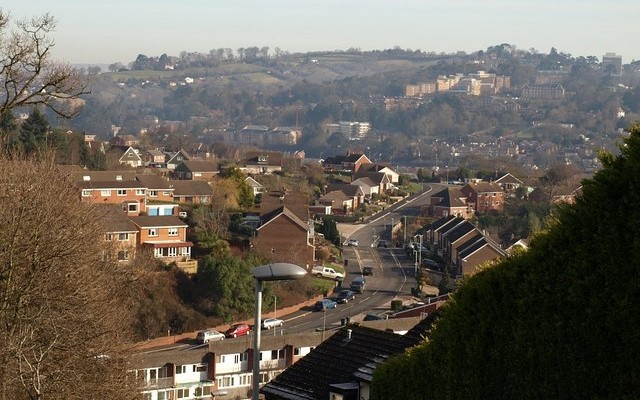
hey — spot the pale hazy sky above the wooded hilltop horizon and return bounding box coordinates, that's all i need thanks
[0,0,640,64]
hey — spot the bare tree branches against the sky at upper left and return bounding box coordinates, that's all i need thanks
[0,9,89,118]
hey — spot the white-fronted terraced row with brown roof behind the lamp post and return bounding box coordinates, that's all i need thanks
[130,331,335,400]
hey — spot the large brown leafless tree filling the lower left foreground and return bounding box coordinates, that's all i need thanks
[0,157,137,400]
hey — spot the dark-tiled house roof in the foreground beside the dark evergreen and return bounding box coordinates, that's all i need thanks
[260,313,437,400]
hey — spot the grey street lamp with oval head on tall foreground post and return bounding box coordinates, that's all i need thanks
[251,263,307,400]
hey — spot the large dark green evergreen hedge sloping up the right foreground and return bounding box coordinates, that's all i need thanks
[371,124,640,400]
